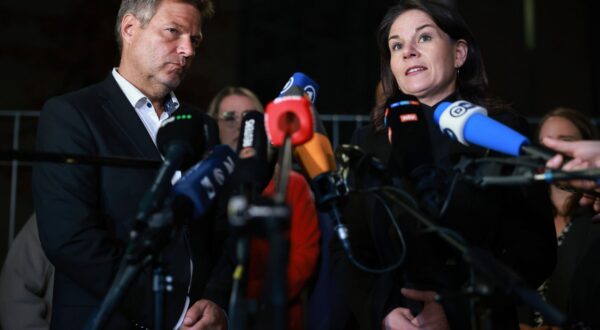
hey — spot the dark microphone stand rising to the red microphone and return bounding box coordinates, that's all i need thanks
[228,136,292,330]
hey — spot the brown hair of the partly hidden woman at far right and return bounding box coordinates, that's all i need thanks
[536,107,599,217]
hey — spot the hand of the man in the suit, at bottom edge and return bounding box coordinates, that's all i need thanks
[181,299,227,330]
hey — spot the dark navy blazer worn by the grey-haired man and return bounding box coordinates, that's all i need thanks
[33,74,223,329]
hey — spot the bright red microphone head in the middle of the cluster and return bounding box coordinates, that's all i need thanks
[265,91,314,147]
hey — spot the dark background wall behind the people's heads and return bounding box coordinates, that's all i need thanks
[0,0,600,261]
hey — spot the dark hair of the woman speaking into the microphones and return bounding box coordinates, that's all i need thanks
[372,0,488,129]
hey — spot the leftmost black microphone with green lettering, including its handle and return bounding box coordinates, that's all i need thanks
[132,112,205,224]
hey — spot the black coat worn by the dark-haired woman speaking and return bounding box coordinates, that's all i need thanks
[334,100,556,329]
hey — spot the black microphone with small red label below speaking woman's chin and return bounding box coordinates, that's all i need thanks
[384,95,448,217]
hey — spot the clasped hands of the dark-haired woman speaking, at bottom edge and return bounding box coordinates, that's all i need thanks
[382,288,450,330]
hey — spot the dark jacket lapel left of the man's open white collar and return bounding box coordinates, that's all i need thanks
[99,73,161,160]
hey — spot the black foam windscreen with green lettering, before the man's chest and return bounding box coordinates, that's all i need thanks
[156,111,206,169]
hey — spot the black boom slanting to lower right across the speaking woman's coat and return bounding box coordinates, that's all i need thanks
[380,187,566,329]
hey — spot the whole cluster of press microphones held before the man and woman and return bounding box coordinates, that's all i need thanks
[133,73,600,260]
